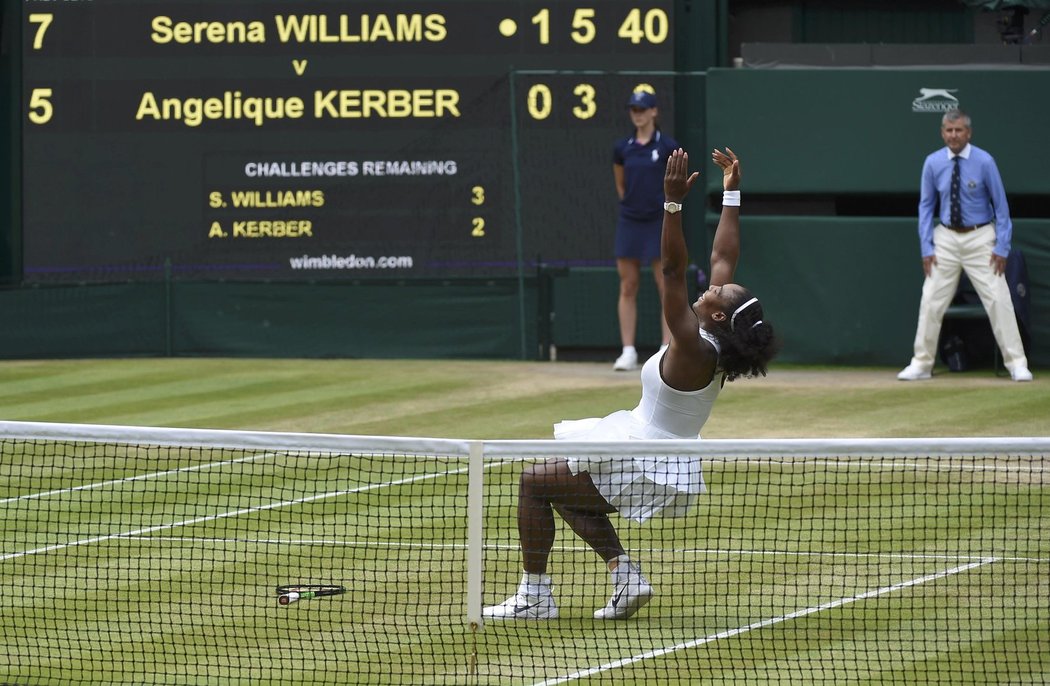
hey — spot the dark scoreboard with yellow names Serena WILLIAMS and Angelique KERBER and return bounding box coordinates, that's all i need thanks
[21,0,675,283]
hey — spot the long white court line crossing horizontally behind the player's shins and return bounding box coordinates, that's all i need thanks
[108,536,1050,564]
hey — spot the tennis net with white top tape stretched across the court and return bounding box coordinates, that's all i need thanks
[0,422,1050,684]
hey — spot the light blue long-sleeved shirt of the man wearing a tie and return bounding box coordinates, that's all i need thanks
[919,143,1013,257]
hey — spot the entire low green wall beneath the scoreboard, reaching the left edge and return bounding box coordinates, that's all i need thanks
[0,279,538,359]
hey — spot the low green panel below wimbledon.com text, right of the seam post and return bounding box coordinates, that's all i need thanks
[173,279,536,358]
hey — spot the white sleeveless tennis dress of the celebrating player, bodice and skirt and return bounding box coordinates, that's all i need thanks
[554,329,721,522]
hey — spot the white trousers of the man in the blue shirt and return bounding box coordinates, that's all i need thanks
[911,224,1028,370]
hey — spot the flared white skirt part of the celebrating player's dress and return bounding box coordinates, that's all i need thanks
[554,410,707,522]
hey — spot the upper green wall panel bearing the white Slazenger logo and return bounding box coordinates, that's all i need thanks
[707,68,1050,194]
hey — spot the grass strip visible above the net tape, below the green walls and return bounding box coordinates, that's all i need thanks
[0,358,1050,438]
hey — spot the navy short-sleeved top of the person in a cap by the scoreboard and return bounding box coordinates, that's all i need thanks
[612,129,678,221]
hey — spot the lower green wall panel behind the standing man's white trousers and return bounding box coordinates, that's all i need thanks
[737,216,1050,367]
